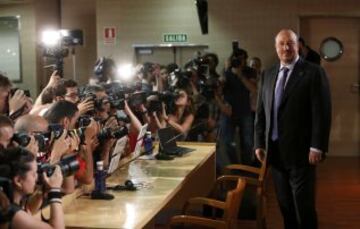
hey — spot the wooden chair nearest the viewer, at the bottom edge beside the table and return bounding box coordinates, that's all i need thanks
[170,176,246,229]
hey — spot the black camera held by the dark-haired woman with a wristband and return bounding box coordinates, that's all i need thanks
[38,155,80,177]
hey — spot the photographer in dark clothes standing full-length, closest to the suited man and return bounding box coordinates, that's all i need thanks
[224,48,256,165]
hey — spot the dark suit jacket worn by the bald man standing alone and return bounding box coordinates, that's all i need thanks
[255,59,331,166]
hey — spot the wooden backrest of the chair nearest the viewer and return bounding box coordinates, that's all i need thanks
[223,178,246,223]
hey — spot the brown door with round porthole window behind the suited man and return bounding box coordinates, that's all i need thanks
[300,16,360,156]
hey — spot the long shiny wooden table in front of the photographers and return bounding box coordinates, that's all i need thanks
[64,143,215,228]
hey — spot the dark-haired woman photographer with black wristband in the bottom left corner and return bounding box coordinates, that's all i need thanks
[0,147,65,229]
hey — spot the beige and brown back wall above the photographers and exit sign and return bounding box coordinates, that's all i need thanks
[96,0,360,70]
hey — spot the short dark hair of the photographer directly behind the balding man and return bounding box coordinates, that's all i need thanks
[43,100,79,123]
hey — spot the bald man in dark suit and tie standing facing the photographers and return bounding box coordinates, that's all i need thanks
[255,30,331,229]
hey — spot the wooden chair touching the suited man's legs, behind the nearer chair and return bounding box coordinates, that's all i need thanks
[225,156,267,229]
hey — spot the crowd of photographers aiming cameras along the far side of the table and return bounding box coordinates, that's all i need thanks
[0,45,261,228]
